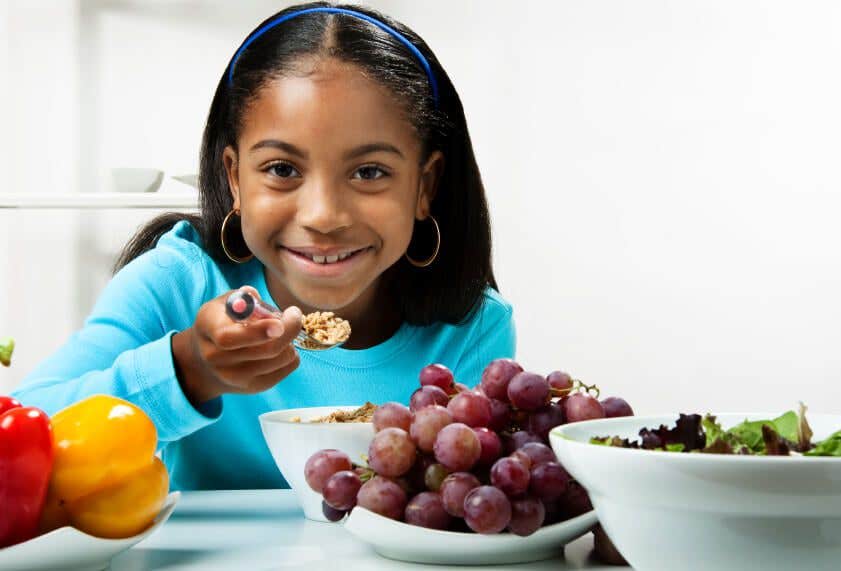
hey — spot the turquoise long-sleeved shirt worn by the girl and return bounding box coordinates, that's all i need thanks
[14,221,515,490]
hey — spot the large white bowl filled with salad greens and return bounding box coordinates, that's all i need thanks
[549,413,841,571]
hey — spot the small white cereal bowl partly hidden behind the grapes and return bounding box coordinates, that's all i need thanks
[260,406,374,521]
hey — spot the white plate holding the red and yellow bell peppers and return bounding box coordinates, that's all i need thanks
[0,492,181,571]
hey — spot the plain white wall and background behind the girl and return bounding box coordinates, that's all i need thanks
[0,0,841,413]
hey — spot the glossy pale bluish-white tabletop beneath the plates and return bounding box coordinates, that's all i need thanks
[111,490,627,571]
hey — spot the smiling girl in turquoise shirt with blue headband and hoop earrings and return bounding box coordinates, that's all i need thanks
[15,3,514,490]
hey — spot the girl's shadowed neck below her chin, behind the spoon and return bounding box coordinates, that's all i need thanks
[264,270,403,349]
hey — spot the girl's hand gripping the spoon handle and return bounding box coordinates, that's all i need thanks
[172,288,302,405]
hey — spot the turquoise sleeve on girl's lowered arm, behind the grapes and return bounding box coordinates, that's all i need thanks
[454,292,517,388]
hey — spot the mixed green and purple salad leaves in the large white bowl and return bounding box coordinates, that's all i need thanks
[590,403,841,457]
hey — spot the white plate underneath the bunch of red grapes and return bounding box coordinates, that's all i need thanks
[344,507,597,565]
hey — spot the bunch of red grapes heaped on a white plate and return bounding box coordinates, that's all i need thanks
[305,359,633,536]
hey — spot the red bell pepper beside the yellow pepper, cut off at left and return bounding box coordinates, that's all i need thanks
[0,396,53,547]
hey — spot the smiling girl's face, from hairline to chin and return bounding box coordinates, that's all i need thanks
[224,59,443,316]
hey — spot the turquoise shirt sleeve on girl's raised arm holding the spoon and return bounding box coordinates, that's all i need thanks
[13,237,222,447]
